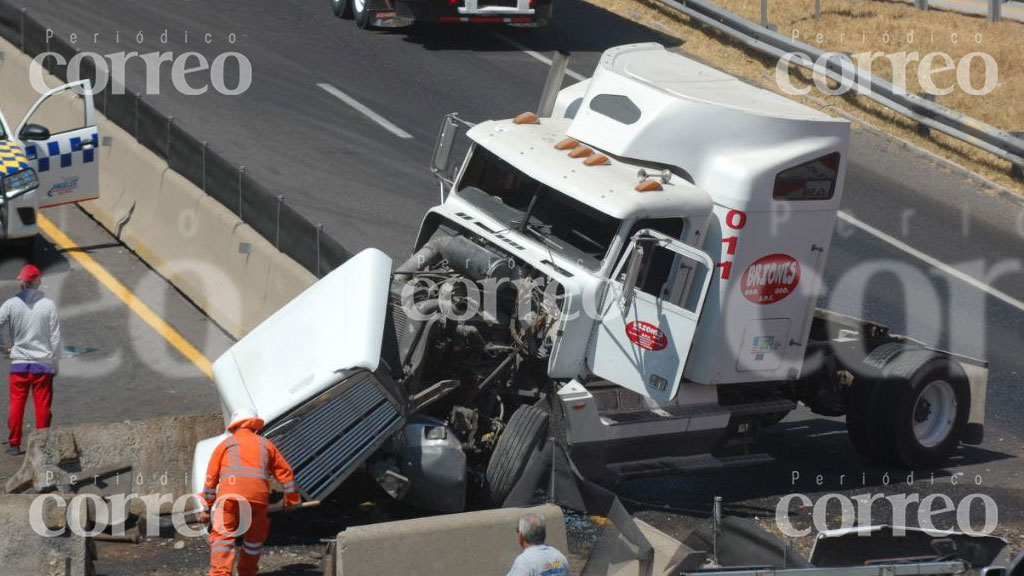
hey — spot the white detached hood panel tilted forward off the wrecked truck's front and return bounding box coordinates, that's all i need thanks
[213,248,391,424]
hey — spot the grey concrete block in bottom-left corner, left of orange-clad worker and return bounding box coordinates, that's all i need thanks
[0,487,96,576]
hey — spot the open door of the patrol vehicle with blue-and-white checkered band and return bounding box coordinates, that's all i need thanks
[16,80,99,208]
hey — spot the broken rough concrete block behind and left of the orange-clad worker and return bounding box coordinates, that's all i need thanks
[4,413,224,513]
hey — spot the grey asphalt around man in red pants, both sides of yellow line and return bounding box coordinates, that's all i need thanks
[0,206,232,478]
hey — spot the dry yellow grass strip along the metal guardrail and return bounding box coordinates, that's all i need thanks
[587,0,1024,195]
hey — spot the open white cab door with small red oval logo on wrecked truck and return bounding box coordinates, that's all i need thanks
[587,230,713,403]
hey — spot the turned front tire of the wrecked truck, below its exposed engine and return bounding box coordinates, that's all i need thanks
[486,405,548,506]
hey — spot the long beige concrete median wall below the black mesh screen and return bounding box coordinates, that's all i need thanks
[0,35,316,337]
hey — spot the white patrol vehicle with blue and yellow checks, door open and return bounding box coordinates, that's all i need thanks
[0,80,99,242]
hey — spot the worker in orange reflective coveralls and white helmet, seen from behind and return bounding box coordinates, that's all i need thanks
[199,409,300,576]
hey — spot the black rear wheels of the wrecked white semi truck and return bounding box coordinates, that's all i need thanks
[847,342,971,469]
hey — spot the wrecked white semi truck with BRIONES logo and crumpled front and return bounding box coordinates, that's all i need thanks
[195,44,987,511]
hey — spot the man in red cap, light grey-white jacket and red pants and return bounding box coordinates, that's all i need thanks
[0,264,60,456]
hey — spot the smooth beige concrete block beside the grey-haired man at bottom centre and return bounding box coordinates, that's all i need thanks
[335,505,566,576]
